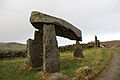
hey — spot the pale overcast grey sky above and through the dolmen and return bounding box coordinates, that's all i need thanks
[0,0,120,46]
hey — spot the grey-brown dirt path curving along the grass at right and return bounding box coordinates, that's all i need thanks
[95,51,120,80]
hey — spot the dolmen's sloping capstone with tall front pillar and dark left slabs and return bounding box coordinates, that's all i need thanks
[27,11,82,73]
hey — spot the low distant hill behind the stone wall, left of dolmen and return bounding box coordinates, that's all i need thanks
[0,42,26,50]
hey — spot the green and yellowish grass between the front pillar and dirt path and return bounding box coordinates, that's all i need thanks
[61,48,111,77]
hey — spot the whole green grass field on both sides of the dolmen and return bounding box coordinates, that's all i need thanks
[0,48,111,80]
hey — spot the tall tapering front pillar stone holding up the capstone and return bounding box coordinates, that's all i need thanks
[43,24,60,73]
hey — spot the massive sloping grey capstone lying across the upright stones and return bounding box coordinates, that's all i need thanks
[30,11,82,41]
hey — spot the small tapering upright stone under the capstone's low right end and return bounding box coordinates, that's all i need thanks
[74,41,83,58]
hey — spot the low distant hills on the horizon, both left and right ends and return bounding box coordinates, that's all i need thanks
[0,40,120,50]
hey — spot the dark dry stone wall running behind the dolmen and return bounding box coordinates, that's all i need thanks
[0,42,95,58]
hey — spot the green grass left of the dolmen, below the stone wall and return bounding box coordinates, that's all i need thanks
[0,58,39,80]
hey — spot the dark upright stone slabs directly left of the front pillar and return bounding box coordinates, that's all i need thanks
[28,29,43,68]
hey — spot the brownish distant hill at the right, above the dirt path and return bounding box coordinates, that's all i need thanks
[101,40,120,47]
